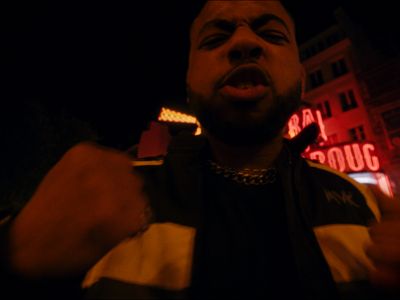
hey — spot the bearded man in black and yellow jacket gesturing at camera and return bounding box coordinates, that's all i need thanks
[3,1,400,299]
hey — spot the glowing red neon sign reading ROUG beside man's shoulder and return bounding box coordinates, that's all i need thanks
[305,143,380,173]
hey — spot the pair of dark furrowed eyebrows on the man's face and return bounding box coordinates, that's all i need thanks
[199,14,290,35]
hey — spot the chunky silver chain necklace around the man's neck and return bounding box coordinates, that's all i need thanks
[208,160,277,185]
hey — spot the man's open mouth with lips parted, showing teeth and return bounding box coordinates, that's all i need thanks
[220,66,269,101]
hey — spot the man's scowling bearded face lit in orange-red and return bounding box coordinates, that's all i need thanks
[187,0,302,145]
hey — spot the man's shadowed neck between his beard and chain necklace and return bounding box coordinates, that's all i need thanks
[207,135,283,170]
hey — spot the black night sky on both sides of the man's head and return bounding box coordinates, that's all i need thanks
[0,0,400,146]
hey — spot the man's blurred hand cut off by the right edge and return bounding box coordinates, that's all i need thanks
[367,190,400,291]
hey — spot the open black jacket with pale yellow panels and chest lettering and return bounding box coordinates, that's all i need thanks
[83,136,380,299]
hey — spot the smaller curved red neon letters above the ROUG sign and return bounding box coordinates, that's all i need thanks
[288,108,328,146]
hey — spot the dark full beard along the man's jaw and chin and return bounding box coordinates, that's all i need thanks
[188,81,302,146]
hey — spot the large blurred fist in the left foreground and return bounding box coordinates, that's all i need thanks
[9,144,148,278]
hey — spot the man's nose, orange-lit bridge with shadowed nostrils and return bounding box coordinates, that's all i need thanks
[228,28,263,64]
